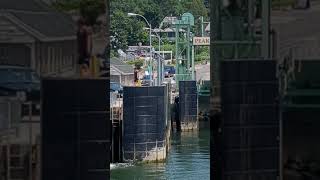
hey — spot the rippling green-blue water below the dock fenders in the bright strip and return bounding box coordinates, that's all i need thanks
[111,125,210,180]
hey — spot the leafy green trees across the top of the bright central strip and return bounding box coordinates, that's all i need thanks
[110,0,208,50]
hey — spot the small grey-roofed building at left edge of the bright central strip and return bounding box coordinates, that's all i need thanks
[110,58,134,86]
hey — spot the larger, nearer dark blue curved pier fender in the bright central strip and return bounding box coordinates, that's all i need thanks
[123,86,171,162]
